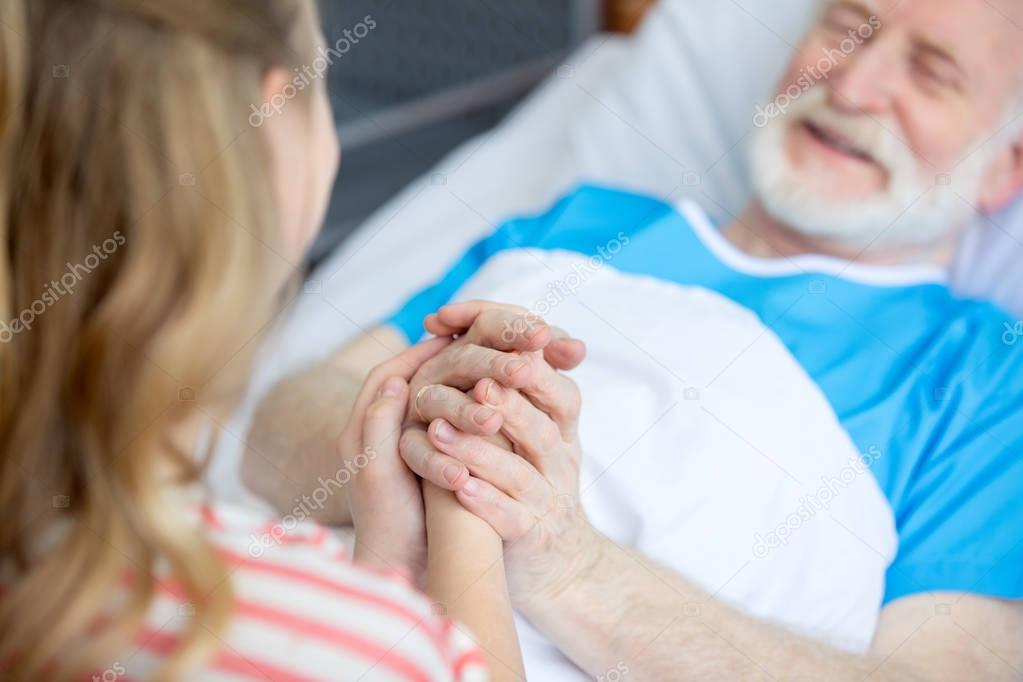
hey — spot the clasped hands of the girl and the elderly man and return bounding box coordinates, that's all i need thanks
[342,302,597,606]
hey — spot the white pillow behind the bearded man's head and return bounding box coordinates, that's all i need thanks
[573,0,1023,315]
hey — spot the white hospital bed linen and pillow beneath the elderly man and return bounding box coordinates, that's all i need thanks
[211,0,1023,502]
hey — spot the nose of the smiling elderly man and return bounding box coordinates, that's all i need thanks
[829,36,898,113]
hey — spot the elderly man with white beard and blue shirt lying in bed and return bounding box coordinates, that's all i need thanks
[246,0,1023,680]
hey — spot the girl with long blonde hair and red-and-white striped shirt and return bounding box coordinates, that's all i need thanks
[0,0,519,680]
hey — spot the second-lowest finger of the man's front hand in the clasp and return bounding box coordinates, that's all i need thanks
[427,419,553,510]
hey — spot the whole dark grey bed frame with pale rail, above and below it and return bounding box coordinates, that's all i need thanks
[310,0,604,266]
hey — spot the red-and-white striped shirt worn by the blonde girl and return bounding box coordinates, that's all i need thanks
[93,505,489,682]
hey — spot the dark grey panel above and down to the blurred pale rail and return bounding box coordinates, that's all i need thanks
[320,0,603,150]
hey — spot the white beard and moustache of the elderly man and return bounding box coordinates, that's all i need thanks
[750,85,991,247]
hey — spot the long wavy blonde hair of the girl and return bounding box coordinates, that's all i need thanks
[0,0,312,680]
